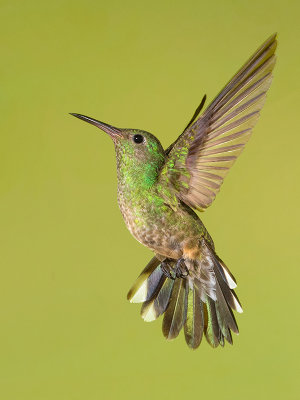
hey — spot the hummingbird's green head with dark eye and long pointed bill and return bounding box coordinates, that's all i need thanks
[71,113,165,187]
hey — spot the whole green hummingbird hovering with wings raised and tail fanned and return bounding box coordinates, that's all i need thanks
[71,34,277,349]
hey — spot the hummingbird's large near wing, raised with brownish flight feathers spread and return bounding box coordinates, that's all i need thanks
[160,34,277,209]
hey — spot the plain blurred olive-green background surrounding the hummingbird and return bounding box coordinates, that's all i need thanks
[0,0,300,400]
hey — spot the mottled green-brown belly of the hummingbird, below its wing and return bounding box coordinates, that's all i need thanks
[119,193,210,259]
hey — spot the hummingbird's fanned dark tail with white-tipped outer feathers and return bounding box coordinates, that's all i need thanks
[127,240,242,349]
